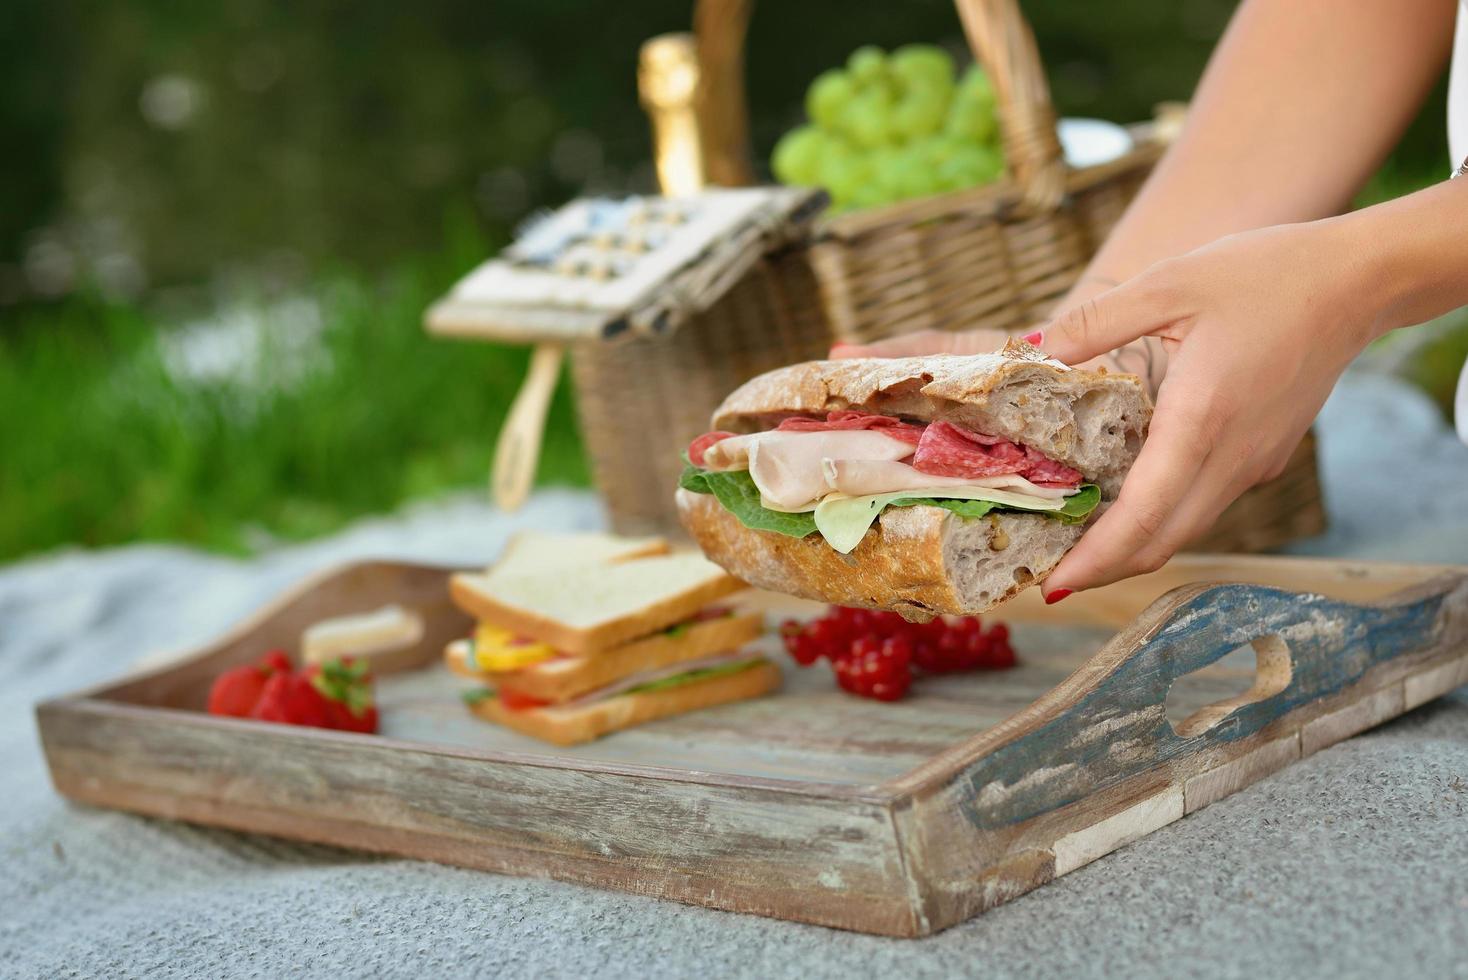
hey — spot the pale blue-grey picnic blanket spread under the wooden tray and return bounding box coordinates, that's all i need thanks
[0,377,1468,980]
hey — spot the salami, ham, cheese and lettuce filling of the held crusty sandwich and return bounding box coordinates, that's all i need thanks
[680,411,1101,555]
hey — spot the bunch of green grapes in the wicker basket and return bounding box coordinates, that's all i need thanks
[771,44,1004,213]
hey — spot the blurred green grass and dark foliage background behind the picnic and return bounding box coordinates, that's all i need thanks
[0,0,1446,560]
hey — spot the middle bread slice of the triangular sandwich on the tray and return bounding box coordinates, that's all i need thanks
[445,616,765,704]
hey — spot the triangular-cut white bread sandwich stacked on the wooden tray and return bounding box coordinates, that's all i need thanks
[445,540,780,744]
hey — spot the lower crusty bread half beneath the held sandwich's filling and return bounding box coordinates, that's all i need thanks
[678,489,1080,619]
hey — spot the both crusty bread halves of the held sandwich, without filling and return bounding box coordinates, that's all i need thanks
[678,342,1152,619]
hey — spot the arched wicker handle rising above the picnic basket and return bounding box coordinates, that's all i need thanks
[693,0,1066,213]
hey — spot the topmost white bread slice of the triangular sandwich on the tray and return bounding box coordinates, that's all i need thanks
[449,552,744,654]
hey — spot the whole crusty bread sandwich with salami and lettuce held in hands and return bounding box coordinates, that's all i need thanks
[677,342,1152,619]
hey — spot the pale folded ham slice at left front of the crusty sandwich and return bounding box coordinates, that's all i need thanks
[751,428,913,511]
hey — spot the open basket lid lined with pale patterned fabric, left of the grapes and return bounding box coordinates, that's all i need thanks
[426,186,826,343]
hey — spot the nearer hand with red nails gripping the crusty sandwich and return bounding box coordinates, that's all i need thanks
[1029,222,1368,600]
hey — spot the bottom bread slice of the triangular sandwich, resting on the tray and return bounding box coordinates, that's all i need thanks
[470,660,780,745]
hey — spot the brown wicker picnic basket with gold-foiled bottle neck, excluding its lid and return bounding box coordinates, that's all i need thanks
[428,0,1324,550]
